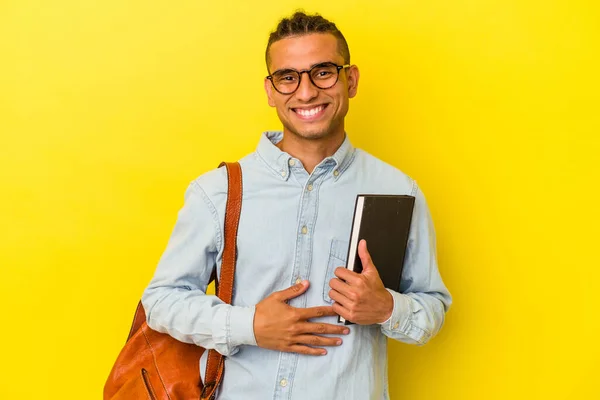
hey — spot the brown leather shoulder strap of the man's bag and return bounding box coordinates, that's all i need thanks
[200,162,243,400]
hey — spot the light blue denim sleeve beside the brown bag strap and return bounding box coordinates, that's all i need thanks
[142,182,256,356]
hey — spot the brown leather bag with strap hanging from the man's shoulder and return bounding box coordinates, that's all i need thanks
[104,163,242,400]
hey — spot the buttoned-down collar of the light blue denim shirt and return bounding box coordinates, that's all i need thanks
[256,131,355,180]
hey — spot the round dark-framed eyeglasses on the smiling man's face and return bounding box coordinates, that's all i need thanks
[267,62,350,94]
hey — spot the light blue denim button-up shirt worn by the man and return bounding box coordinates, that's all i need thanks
[142,132,451,400]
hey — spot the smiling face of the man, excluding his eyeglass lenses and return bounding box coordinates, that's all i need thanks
[265,33,359,140]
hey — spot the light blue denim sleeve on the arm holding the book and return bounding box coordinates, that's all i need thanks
[380,183,452,345]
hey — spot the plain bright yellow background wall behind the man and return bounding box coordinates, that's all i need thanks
[0,0,600,400]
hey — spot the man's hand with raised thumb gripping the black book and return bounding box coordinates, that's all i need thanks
[329,240,394,325]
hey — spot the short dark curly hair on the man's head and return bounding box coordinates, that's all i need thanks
[265,11,350,69]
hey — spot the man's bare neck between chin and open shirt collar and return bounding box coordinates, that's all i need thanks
[277,130,345,174]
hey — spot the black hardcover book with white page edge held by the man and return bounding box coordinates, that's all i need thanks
[339,194,415,325]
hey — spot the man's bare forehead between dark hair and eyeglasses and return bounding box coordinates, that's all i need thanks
[269,33,343,71]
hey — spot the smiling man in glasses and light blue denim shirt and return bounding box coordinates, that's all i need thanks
[142,12,451,400]
